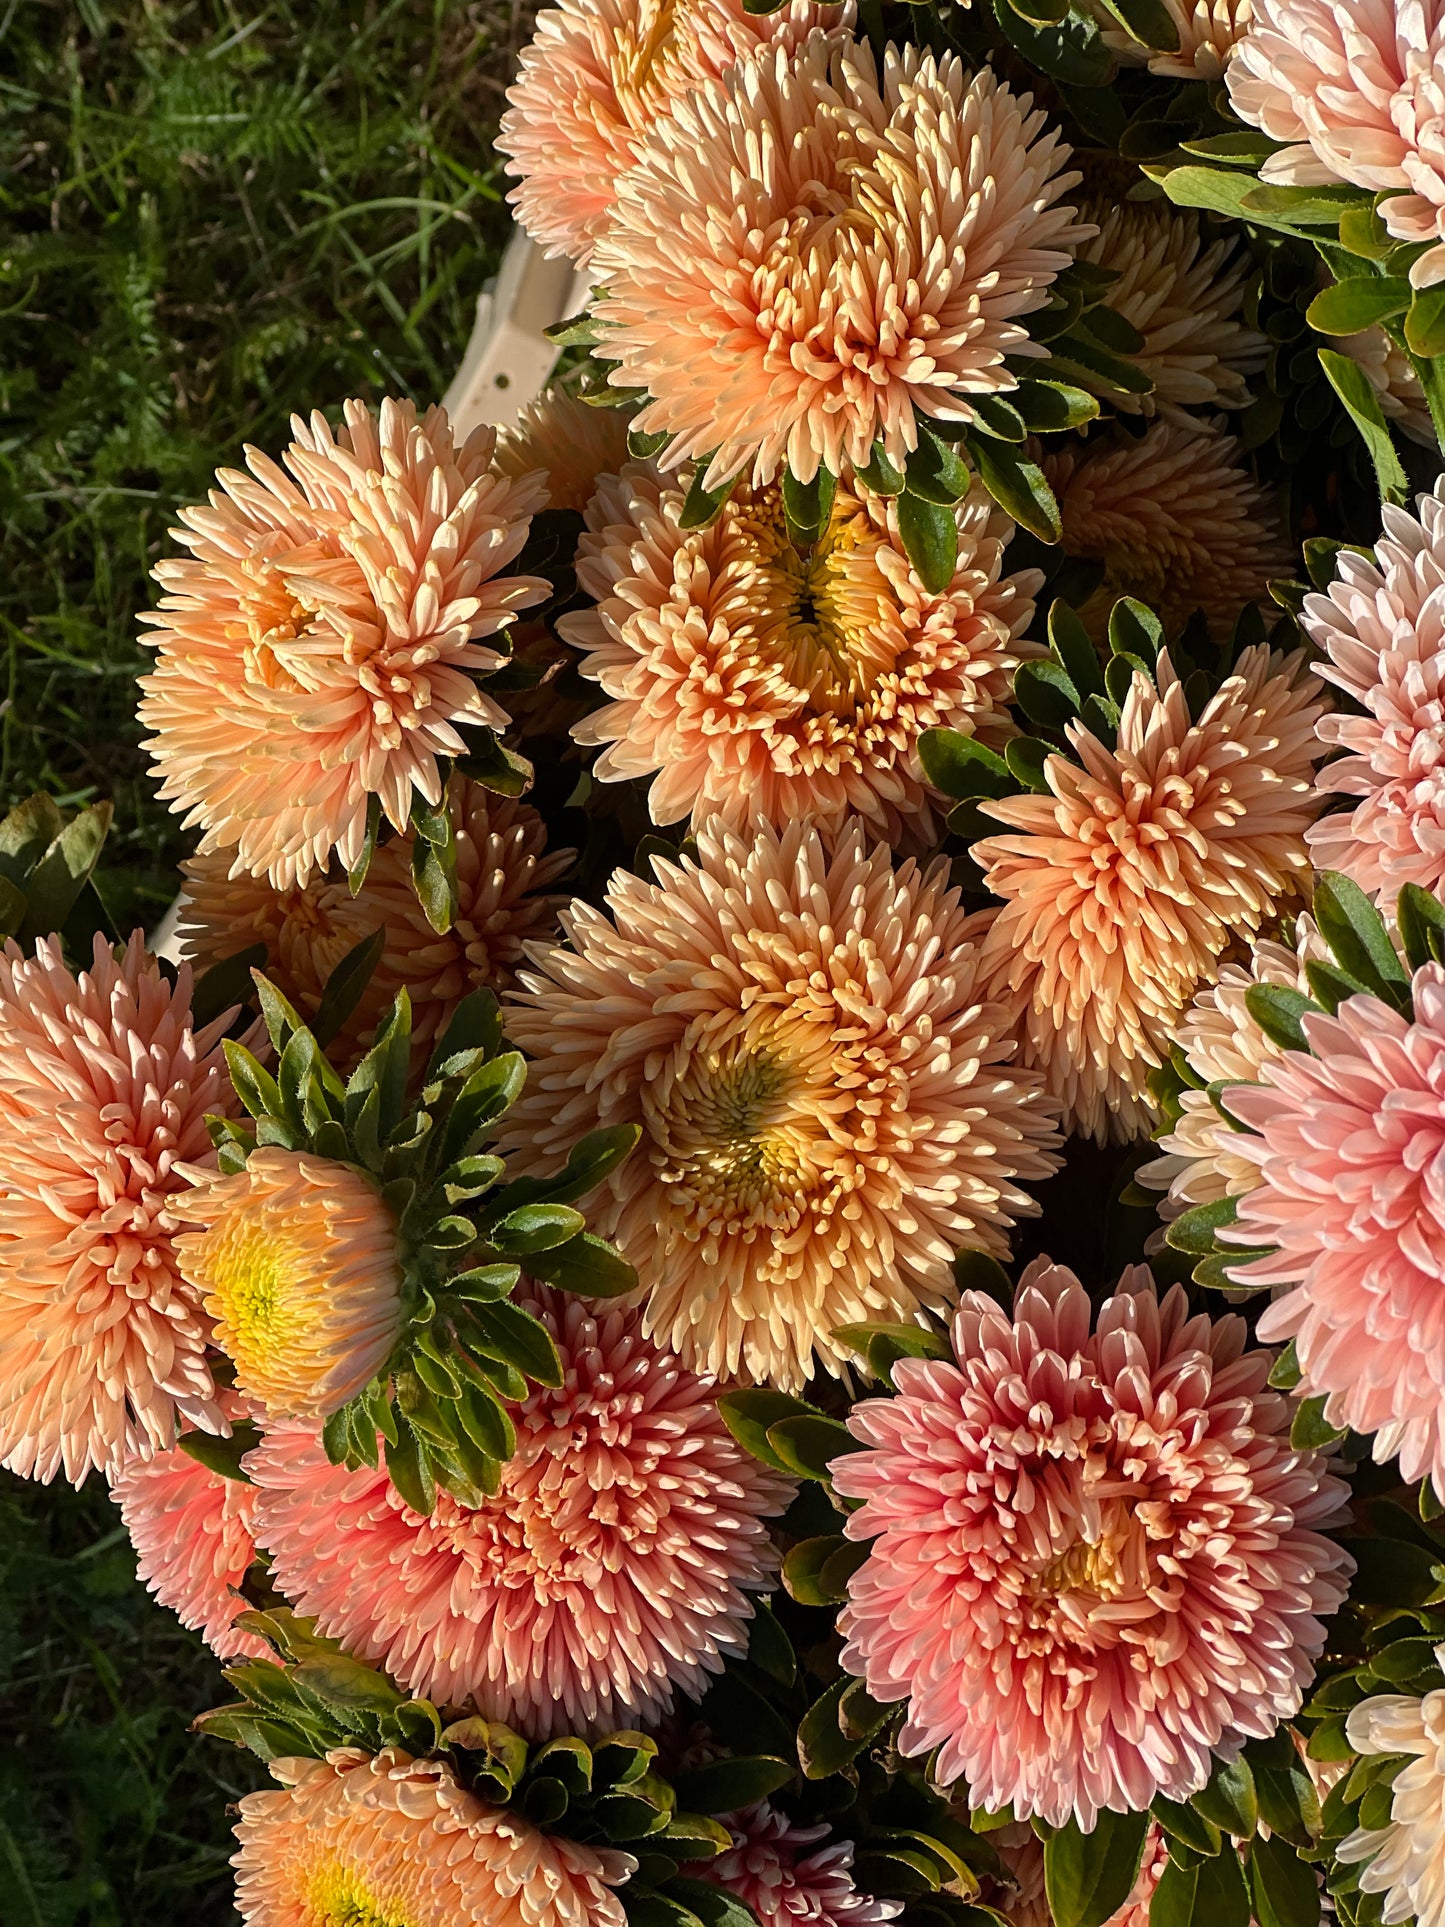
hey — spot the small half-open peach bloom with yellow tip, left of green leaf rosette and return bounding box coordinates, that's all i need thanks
[175,1145,401,1418]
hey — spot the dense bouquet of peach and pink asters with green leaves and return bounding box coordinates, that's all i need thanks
[14,0,1445,1927]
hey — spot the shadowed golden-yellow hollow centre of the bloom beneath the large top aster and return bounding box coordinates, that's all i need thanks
[730,486,894,717]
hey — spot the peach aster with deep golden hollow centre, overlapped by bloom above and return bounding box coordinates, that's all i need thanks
[559,462,1042,842]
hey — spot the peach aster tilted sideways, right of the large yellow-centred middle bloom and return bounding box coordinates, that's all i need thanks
[973,644,1320,1143]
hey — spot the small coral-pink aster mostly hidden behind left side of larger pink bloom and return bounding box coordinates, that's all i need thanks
[110,1393,272,1659]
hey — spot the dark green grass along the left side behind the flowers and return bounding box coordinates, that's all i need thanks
[0,0,526,1927]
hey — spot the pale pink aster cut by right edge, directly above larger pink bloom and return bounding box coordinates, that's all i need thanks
[1302,484,1445,908]
